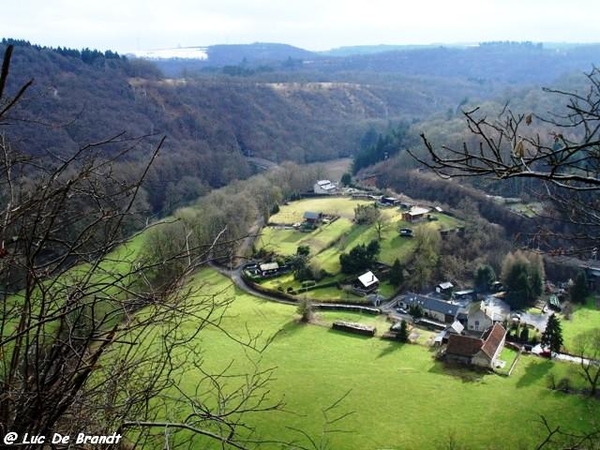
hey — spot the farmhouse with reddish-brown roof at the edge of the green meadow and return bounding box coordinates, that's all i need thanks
[444,323,506,369]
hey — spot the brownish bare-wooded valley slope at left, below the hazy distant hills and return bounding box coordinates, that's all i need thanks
[0,41,496,213]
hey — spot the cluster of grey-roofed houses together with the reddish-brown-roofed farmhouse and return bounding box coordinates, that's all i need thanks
[398,283,510,369]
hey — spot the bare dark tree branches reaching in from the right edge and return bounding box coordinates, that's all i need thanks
[410,68,600,257]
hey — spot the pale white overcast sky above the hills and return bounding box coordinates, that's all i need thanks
[0,0,600,53]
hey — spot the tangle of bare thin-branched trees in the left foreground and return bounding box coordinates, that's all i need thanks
[0,46,288,448]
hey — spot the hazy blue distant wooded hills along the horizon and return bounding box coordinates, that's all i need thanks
[150,42,600,85]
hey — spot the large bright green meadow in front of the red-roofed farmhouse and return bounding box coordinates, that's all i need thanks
[149,270,600,449]
